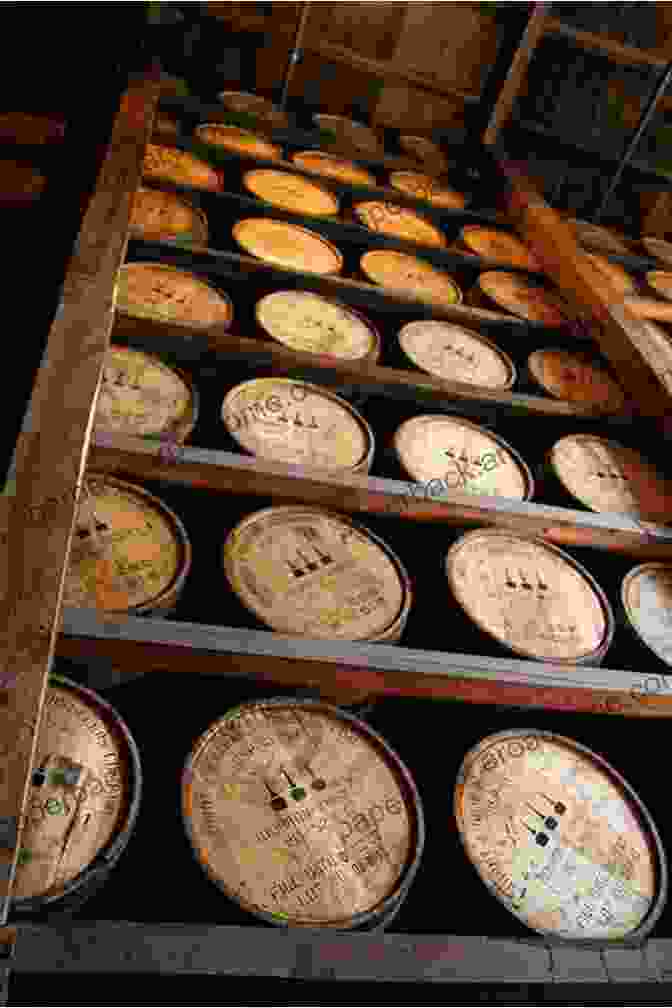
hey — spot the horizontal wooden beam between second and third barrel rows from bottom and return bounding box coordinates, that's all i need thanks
[89,433,672,562]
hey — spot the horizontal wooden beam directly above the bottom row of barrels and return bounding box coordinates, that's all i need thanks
[58,609,672,718]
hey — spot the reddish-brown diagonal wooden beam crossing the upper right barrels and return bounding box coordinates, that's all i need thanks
[501,162,672,425]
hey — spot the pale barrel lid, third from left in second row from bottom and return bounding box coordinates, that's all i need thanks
[445,529,614,662]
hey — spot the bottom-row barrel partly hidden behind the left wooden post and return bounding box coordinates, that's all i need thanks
[8,675,142,918]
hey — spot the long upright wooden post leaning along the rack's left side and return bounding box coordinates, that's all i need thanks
[0,75,158,921]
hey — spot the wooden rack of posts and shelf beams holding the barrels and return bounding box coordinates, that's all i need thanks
[6,23,672,999]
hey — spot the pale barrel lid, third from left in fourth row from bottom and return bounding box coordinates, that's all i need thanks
[398,320,516,388]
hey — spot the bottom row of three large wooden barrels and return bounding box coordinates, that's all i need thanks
[10,675,667,940]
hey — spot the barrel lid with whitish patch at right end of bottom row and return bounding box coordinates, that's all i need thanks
[454,730,664,940]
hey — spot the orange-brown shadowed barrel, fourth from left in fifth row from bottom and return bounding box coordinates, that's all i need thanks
[466,270,567,326]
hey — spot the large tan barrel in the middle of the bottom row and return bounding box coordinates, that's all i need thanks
[182,699,424,930]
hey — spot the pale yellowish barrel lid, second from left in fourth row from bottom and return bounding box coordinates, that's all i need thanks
[256,290,380,361]
